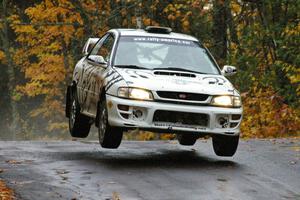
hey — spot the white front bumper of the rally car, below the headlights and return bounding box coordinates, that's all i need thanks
[106,95,243,135]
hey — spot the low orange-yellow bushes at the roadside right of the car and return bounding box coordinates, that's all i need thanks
[241,84,300,137]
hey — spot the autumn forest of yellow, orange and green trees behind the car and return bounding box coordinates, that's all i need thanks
[0,0,300,139]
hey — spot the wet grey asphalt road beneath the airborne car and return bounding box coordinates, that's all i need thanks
[0,139,300,200]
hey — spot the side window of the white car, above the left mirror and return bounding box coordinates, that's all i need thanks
[90,34,114,62]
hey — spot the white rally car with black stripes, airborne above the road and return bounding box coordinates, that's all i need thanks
[66,27,243,156]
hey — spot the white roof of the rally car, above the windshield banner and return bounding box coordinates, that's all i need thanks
[110,28,198,42]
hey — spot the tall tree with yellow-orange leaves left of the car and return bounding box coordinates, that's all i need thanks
[10,0,83,130]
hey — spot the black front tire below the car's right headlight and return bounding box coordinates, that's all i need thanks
[212,135,239,156]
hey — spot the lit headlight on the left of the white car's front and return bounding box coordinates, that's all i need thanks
[118,87,153,100]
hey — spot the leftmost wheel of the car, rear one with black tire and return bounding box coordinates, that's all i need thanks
[69,90,91,138]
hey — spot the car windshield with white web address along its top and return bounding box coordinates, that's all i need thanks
[114,36,220,74]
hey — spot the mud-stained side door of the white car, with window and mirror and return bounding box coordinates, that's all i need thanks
[81,34,115,117]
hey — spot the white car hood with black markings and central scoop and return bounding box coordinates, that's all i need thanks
[115,68,238,95]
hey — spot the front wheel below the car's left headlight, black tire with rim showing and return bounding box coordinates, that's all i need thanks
[98,99,123,149]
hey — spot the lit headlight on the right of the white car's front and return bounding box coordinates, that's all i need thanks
[211,96,242,107]
